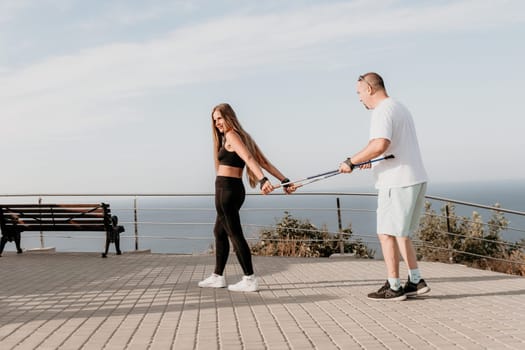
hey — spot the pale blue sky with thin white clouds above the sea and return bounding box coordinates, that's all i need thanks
[0,0,525,194]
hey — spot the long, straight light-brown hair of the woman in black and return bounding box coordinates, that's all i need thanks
[211,103,268,188]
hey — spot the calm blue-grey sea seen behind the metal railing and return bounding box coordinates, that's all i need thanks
[3,180,525,257]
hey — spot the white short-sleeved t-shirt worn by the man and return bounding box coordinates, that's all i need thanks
[370,97,427,189]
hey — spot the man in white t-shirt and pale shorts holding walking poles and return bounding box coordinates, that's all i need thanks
[339,73,430,300]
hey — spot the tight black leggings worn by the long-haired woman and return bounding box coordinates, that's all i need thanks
[213,176,253,276]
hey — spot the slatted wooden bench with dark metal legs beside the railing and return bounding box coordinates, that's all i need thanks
[0,203,124,258]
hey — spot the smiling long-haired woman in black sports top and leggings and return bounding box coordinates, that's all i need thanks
[199,103,295,292]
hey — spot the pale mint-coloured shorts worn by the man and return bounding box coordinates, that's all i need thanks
[377,182,427,237]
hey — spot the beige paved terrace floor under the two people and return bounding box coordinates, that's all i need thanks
[0,252,525,350]
